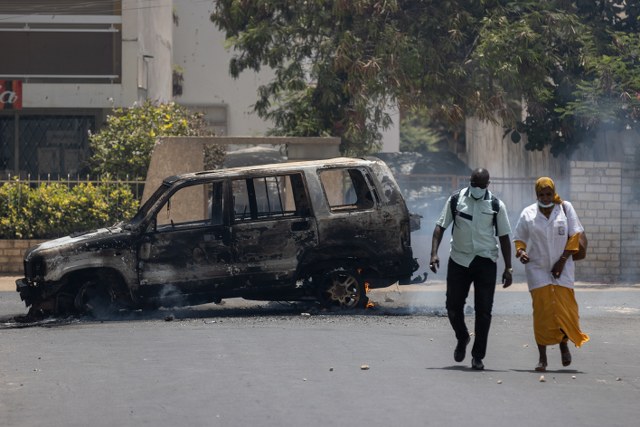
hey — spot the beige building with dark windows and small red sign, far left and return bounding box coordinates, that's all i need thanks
[0,0,172,178]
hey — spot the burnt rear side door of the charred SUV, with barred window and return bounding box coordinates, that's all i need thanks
[231,173,318,287]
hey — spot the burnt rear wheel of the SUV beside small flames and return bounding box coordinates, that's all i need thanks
[318,268,369,309]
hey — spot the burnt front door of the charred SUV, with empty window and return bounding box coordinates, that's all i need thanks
[139,181,232,300]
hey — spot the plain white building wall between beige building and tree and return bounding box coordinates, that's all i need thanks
[173,0,400,152]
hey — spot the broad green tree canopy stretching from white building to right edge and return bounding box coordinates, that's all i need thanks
[211,0,640,153]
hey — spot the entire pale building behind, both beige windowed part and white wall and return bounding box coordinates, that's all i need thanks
[0,0,399,179]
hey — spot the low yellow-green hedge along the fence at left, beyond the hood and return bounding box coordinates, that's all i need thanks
[0,181,138,239]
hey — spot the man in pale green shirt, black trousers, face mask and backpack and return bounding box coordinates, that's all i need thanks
[429,168,513,370]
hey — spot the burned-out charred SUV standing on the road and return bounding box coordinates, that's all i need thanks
[16,158,418,314]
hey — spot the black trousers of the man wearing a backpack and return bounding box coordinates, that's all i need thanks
[447,256,497,359]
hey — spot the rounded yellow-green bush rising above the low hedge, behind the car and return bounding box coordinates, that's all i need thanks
[90,101,224,179]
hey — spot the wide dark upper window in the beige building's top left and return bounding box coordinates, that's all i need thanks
[0,0,122,83]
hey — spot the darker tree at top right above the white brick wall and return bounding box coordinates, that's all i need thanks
[482,0,640,155]
